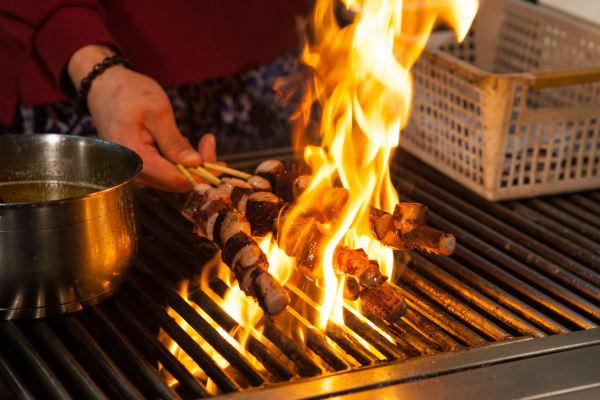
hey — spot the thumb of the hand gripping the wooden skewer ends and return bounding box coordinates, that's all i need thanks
[144,102,203,167]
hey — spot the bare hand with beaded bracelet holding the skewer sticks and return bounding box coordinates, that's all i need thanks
[67,45,216,192]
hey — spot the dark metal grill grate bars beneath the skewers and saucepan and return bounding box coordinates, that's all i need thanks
[0,149,600,399]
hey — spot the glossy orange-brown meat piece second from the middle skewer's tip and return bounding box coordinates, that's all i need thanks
[333,246,387,288]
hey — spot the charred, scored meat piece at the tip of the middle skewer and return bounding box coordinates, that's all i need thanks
[360,282,407,324]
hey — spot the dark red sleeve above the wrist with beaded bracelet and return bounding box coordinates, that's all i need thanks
[0,0,120,92]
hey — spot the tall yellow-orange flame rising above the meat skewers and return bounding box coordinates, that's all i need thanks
[295,0,478,329]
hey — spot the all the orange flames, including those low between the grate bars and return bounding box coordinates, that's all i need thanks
[163,0,478,378]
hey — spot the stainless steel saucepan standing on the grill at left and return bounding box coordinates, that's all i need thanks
[0,134,142,319]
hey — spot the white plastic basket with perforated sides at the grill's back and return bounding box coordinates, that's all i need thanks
[400,0,600,201]
